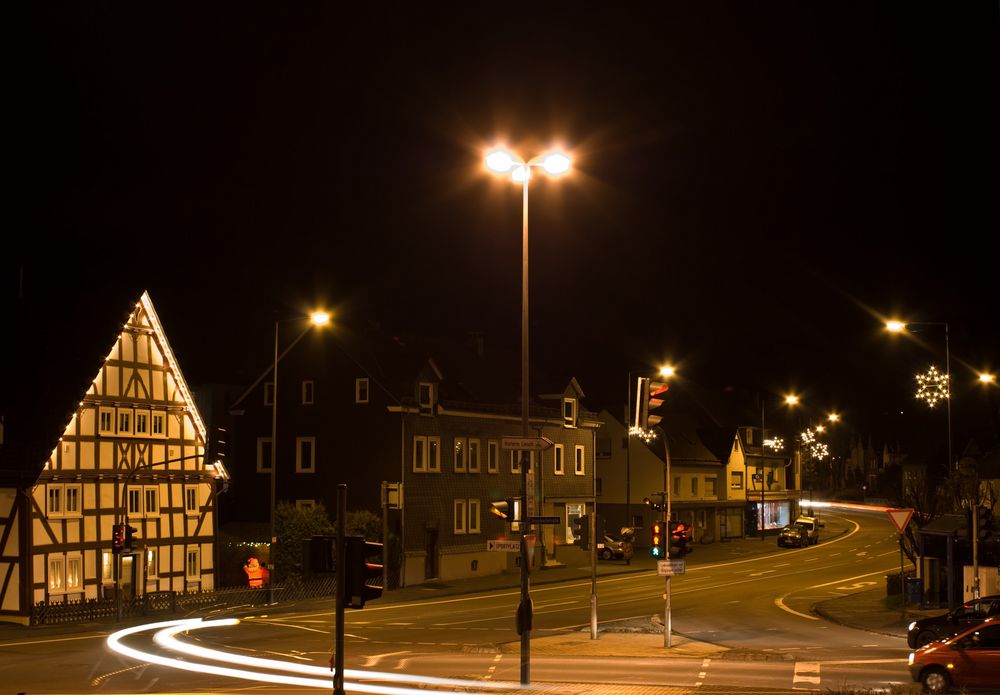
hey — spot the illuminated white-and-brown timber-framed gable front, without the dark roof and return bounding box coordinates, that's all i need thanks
[0,292,216,622]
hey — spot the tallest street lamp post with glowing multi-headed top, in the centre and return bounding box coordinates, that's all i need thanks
[485,149,570,685]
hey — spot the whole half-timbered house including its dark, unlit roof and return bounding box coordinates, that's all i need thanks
[0,292,218,623]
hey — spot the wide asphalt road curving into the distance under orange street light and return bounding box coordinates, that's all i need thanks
[0,512,909,693]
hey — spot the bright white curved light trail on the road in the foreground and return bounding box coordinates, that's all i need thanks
[107,618,517,695]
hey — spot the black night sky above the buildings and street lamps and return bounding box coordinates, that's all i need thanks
[9,1,1000,452]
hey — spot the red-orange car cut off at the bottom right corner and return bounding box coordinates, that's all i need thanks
[907,617,1000,693]
